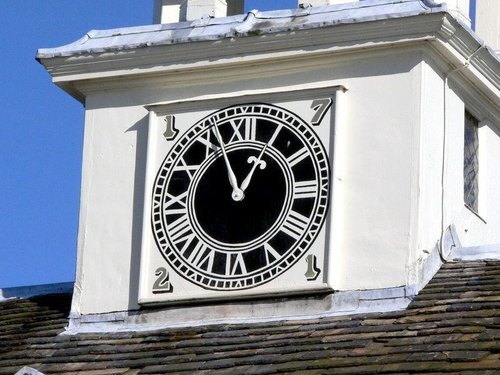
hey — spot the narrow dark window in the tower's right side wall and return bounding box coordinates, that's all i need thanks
[464,111,479,212]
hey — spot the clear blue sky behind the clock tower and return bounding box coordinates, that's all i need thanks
[0,0,296,288]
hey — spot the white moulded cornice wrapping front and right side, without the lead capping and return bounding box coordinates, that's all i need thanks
[39,11,500,113]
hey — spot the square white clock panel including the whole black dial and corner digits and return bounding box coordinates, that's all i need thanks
[139,88,336,304]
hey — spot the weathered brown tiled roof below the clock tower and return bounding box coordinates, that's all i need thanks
[0,261,500,374]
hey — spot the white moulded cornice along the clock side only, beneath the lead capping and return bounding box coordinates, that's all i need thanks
[42,14,443,82]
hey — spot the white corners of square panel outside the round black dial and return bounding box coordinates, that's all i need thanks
[139,88,340,305]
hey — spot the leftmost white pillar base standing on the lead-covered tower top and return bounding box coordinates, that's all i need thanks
[153,0,243,23]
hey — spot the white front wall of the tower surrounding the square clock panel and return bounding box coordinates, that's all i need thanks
[73,49,421,315]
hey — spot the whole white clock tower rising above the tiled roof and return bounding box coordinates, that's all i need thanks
[37,0,500,331]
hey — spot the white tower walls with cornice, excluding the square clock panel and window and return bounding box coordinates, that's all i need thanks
[39,0,500,323]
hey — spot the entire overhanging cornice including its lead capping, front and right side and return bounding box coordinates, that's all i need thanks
[37,0,500,106]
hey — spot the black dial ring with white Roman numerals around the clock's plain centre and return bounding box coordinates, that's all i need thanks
[151,103,330,291]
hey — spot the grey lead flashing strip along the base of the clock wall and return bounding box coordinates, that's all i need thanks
[64,287,414,335]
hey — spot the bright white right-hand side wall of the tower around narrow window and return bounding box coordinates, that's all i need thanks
[413,60,500,261]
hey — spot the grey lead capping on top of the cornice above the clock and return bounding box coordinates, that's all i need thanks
[37,0,446,60]
